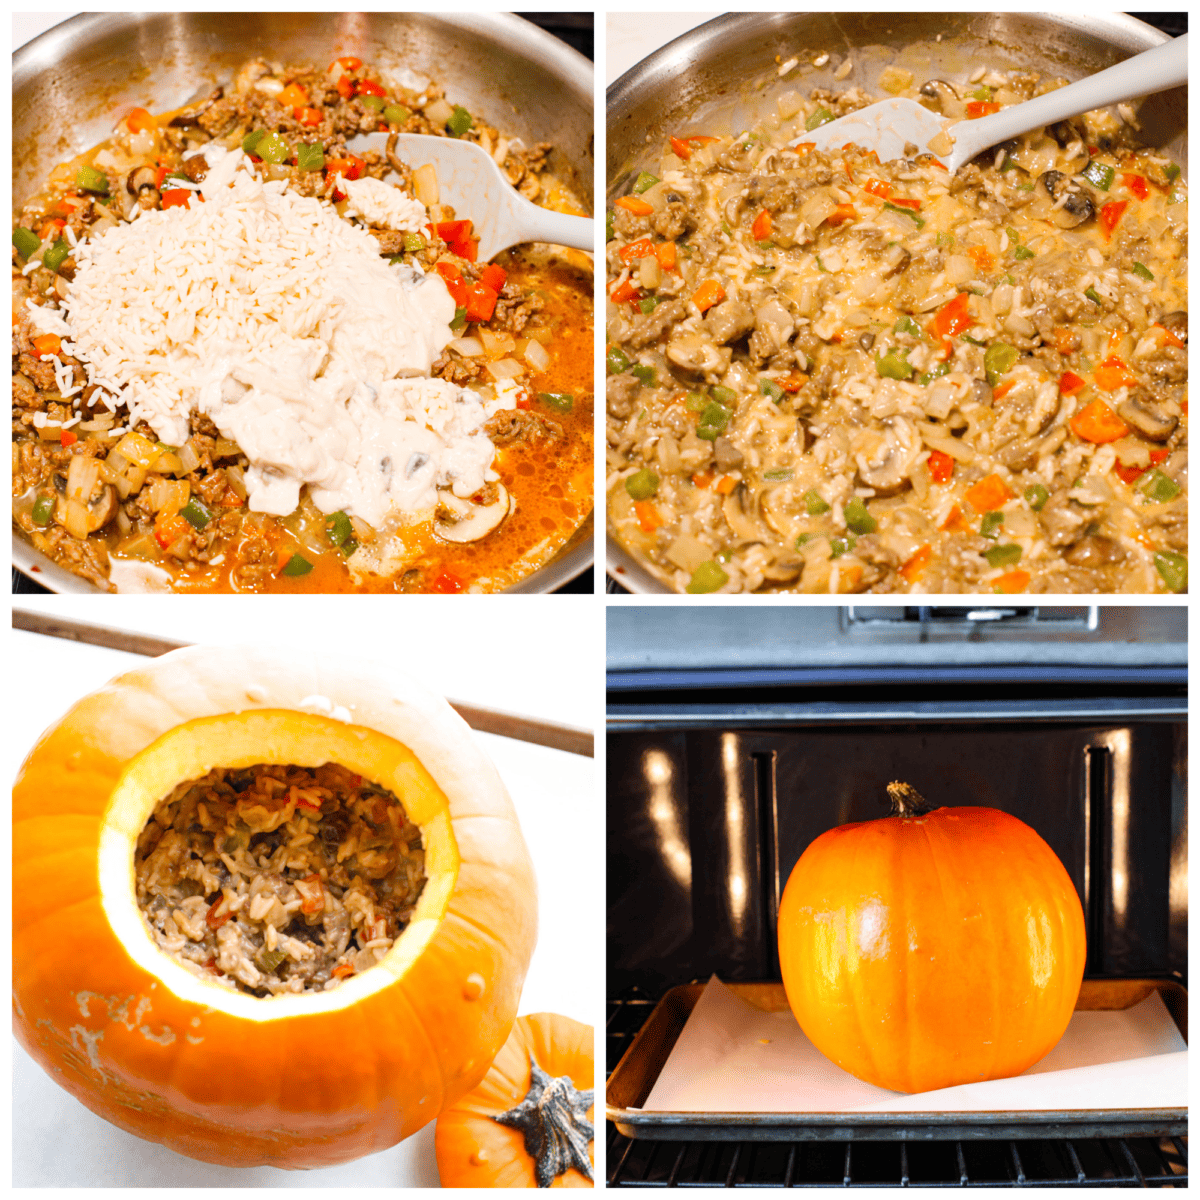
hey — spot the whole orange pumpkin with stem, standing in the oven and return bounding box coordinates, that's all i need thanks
[779,784,1086,1092]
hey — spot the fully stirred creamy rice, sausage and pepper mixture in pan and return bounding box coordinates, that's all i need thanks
[607,68,1187,594]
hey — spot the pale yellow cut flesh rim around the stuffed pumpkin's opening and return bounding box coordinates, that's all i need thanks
[97,709,461,1022]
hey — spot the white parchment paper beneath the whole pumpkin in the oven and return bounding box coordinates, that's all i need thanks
[644,977,1188,1112]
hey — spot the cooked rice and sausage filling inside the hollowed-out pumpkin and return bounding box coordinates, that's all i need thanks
[136,763,425,996]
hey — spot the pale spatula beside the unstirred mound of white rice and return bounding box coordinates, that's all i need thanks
[350,133,595,263]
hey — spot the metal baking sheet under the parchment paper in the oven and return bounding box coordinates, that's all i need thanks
[606,979,1188,1141]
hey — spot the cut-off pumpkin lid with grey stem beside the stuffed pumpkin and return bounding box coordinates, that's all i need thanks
[436,1013,595,1188]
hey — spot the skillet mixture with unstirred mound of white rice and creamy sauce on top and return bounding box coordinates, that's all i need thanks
[12,56,592,592]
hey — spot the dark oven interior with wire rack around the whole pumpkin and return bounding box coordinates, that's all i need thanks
[607,607,1187,1186]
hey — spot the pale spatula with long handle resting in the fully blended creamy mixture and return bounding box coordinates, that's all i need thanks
[792,34,1188,173]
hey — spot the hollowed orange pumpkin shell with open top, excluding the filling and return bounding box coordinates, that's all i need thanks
[12,647,536,1168]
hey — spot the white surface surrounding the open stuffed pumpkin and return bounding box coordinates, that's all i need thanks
[11,596,604,1188]
